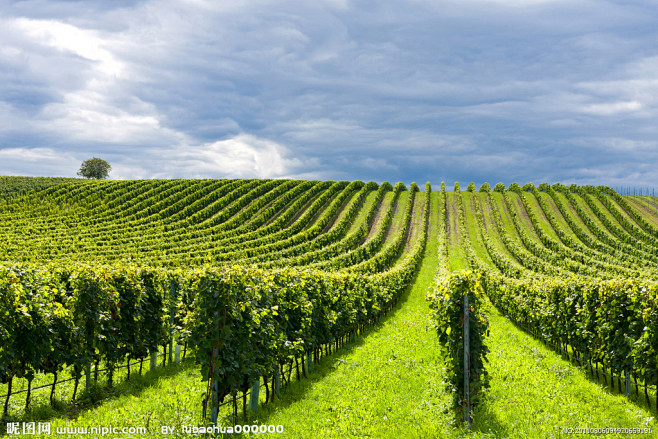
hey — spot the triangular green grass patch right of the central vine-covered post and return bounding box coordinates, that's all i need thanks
[473,306,658,438]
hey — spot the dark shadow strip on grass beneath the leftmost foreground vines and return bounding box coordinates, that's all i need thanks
[0,355,195,436]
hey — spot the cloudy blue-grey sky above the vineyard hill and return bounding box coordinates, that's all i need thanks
[0,0,658,186]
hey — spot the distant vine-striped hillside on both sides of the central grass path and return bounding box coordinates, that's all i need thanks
[0,177,658,278]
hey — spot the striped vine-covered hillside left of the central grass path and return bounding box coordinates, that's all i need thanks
[0,179,423,271]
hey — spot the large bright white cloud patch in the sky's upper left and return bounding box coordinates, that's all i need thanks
[0,18,188,145]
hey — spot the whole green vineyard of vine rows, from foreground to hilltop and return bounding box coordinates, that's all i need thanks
[0,177,658,437]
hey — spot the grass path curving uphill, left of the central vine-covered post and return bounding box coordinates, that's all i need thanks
[254,191,454,438]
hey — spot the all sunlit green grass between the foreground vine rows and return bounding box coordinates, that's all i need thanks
[12,296,658,438]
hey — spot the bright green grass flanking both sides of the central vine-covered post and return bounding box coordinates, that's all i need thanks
[259,194,658,438]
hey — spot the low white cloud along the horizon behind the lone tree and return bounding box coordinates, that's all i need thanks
[0,134,308,179]
